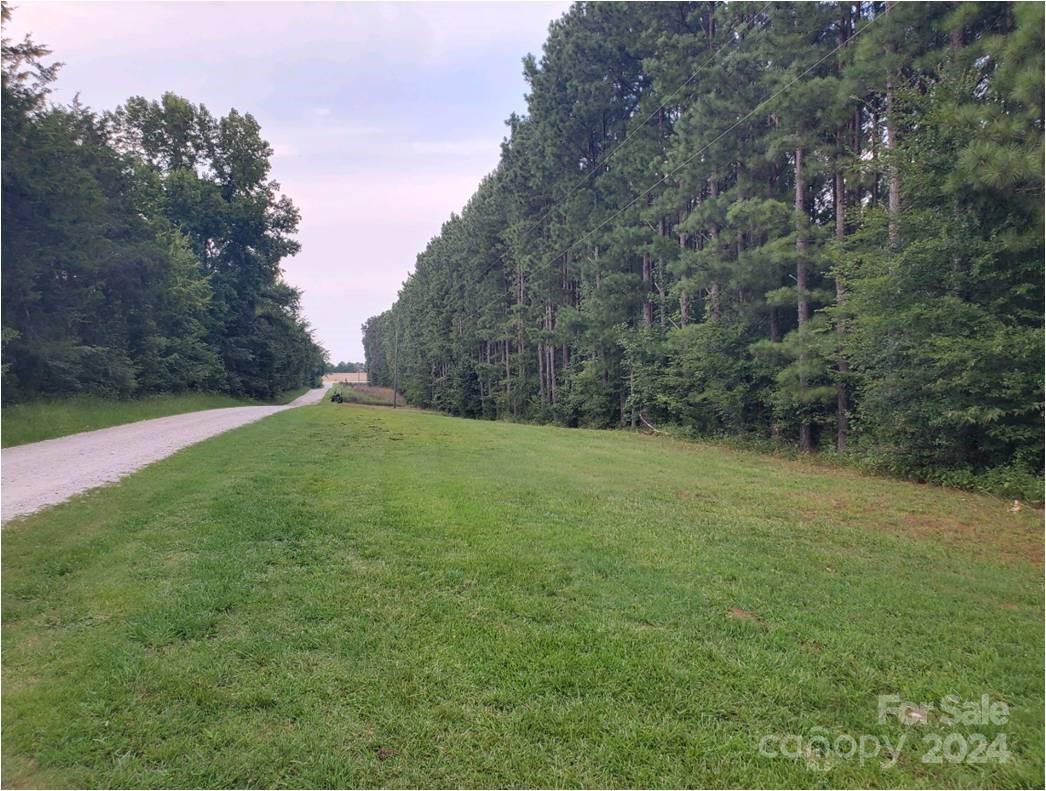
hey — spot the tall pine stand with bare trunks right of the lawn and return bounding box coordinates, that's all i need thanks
[363,2,1044,491]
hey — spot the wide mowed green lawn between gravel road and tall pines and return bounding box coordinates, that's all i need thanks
[2,403,1044,787]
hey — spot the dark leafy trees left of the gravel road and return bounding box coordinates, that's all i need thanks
[2,6,326,403]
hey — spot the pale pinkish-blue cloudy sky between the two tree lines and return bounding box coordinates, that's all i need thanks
[4,0,568,361]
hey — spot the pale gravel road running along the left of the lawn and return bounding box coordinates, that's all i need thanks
[0,387,326,522]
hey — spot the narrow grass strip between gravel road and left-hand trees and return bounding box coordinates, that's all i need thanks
[0,387,309,448]
